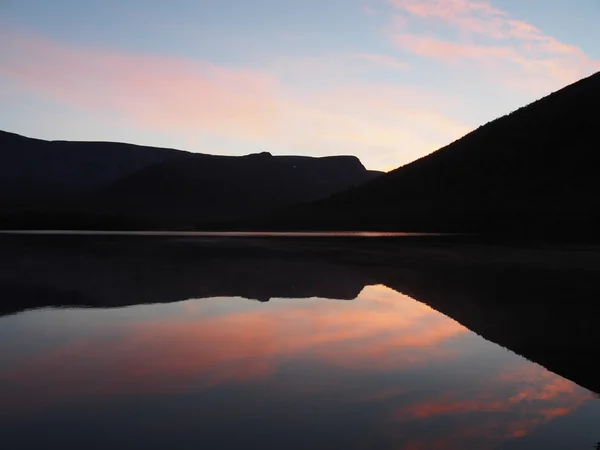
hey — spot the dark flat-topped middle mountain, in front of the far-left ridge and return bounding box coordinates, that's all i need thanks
[80,153,378,226]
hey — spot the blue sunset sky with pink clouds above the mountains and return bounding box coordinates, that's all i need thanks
[0,0,600,170]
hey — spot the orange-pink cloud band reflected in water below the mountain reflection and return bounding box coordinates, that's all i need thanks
[5,286,467,400]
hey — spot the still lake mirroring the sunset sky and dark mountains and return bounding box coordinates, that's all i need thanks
[0,237,600,450]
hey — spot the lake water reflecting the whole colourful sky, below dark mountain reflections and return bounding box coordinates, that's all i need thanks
[0,286,600,450]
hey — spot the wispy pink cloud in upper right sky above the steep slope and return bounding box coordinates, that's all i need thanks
[389,0,600,90]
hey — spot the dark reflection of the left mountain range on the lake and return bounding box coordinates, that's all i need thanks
[0,236,364,315]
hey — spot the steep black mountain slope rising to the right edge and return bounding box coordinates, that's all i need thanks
[252,73,600,232]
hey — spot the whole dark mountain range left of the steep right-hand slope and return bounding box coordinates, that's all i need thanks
[0,132,380,229]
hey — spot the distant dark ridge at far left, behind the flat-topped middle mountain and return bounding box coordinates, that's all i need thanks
[0,131,189,211]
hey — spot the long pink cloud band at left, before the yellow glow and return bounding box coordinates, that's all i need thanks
[0,27,278,137]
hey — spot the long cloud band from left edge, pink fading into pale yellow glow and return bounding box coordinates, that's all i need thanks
[0,26,469,169]
